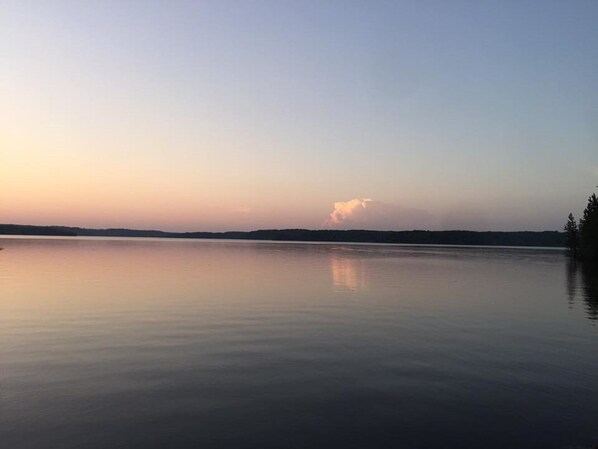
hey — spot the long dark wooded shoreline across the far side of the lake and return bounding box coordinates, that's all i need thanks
[0,224,565,248]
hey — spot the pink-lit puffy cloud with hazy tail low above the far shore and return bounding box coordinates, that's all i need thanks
[322,198,435,230]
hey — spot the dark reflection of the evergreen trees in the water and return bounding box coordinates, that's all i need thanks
[566,260,598,321]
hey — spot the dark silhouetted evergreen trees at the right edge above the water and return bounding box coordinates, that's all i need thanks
[564,193,598,262]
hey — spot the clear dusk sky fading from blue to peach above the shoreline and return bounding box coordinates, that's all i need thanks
[0,0,598,231]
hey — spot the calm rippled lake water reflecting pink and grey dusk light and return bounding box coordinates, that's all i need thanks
[0,238,598,449]
